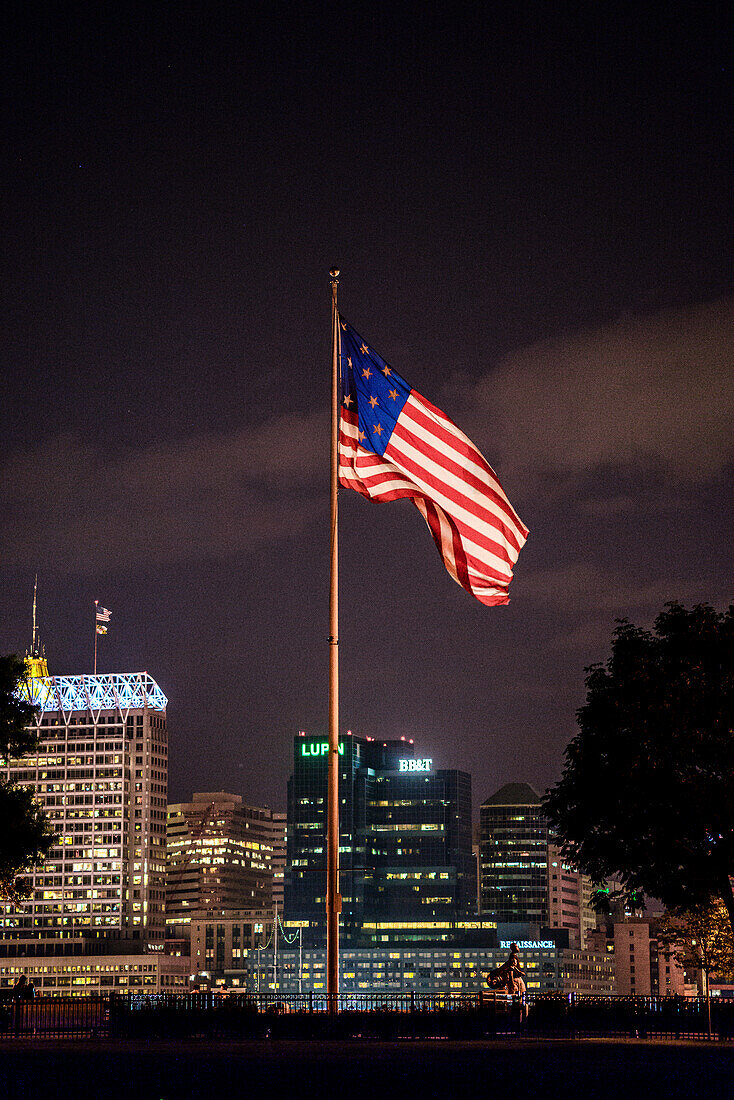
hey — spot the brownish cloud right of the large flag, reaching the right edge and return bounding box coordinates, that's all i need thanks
[465,298,734,487]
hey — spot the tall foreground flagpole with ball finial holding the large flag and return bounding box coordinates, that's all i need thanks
[326,267,341,1012]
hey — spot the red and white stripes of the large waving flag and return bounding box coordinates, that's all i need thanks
[339,389,527,606]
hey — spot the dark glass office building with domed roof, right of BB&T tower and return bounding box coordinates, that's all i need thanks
[480,783,549,927]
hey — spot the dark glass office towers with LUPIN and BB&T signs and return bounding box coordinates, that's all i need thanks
[285,733,478,947]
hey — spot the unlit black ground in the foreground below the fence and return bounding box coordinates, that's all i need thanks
[0,1040,734,1100]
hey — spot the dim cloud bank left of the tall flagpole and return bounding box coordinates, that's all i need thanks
[0,415,328,573]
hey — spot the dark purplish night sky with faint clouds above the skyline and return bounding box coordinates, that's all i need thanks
[0,3,734,809]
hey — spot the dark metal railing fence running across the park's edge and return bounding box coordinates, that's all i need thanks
[0,992,734,1044]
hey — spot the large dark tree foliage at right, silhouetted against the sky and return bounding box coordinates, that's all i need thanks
[544,603,734,928]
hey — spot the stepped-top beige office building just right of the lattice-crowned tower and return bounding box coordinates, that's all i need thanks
[166,791,280,935]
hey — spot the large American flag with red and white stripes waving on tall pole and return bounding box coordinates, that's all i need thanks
[339,318,527,605]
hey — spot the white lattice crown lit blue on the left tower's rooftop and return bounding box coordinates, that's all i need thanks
[21,672,168,716]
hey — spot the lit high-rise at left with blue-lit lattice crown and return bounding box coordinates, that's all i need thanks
[0,660,183,992]
